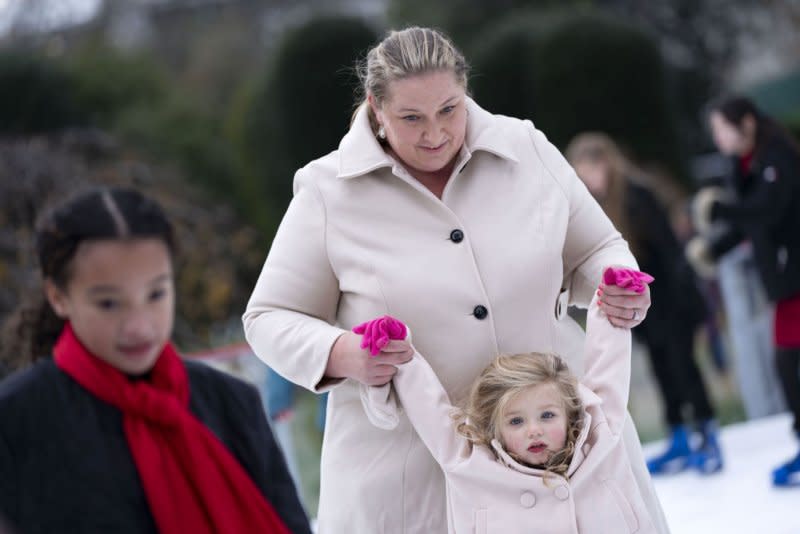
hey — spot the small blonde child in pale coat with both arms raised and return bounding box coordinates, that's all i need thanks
[355,270,656,534]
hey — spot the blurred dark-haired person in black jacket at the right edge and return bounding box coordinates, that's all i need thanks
[687,96,800,486]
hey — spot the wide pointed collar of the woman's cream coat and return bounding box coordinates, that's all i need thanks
[336,97,519,178]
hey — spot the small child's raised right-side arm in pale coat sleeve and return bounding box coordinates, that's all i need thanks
[581,272,652,434]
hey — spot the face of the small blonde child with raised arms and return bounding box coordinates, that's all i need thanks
[499,383,567,465]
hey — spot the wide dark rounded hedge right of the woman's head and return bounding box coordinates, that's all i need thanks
[473,11,686,179]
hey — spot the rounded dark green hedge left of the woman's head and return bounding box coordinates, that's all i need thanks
[238,17,377,209]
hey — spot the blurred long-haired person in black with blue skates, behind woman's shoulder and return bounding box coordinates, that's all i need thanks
[565,132,723,474]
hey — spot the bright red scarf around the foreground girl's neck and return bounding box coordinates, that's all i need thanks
[53,323,289,534]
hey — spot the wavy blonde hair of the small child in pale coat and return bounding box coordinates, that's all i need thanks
[454,353,583,477]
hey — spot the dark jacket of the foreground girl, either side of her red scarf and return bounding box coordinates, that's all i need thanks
[0,358,310,534]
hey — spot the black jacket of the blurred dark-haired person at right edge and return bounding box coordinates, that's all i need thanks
[711,133,800,301]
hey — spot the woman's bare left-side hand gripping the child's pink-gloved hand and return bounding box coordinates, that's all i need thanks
[325,332,414,386]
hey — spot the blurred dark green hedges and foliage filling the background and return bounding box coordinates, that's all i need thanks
[0,0,800,356]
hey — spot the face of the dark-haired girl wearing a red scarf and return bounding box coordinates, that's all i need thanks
[46,239,175,375]
